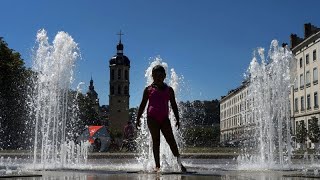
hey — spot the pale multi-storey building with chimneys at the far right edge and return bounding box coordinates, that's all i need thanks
[290,23,320,147]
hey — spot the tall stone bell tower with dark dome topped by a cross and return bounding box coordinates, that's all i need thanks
[109,31,130,137]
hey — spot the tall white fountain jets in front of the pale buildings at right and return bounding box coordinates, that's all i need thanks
[238,40,295,170]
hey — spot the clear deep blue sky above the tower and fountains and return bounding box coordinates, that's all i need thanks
[0,0,320,107]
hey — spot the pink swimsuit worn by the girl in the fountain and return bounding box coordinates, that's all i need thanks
[147,85,170,123]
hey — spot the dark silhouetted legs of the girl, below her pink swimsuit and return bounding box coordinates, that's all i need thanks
[147,118,179,168]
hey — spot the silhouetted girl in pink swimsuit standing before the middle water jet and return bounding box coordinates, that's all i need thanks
[136,65,186,172]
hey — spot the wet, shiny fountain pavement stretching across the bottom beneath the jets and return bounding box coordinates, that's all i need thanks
[0,155,320,180]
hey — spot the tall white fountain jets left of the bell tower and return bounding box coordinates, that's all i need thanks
[30,29,87,168]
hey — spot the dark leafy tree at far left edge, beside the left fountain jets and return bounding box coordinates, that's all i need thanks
[0,37,33,149]
